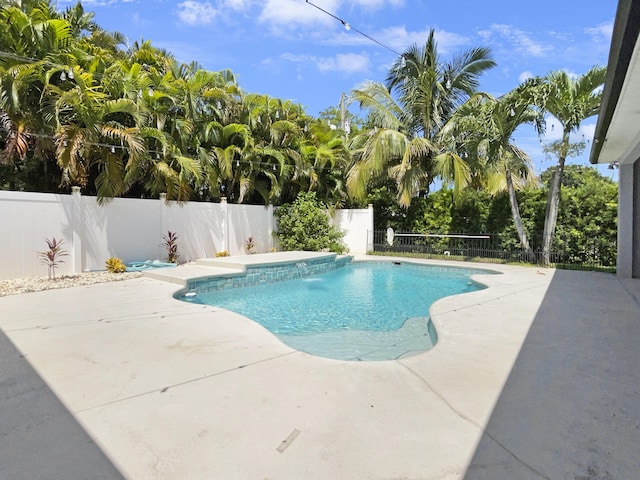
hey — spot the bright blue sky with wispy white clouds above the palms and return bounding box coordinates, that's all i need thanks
[58,0,617,176]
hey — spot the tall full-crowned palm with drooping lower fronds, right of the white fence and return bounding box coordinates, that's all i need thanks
[348,30,495,207]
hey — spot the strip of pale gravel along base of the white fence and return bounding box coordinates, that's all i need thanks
[0,272,142,297]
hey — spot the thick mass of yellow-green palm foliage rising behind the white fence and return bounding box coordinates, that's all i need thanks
[0,1,350,205]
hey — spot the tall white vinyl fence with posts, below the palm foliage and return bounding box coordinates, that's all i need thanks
[0,189,373,280]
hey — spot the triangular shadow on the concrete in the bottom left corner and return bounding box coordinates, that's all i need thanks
[0,330,124,480]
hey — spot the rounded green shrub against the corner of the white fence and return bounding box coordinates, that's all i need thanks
[274,192,346,253]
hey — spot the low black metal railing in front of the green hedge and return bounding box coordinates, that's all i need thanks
[373,230,616,270]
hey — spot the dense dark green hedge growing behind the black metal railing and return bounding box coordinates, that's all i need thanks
[369,165,618,267]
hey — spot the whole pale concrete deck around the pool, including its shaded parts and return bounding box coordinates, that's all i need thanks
[0,253,640,480]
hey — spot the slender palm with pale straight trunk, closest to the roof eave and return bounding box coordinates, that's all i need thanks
[538,66,606,265]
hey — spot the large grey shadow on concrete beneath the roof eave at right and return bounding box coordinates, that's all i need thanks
[463,270,640,480]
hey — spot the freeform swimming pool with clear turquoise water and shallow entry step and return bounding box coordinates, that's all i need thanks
[178,261,493,360]
